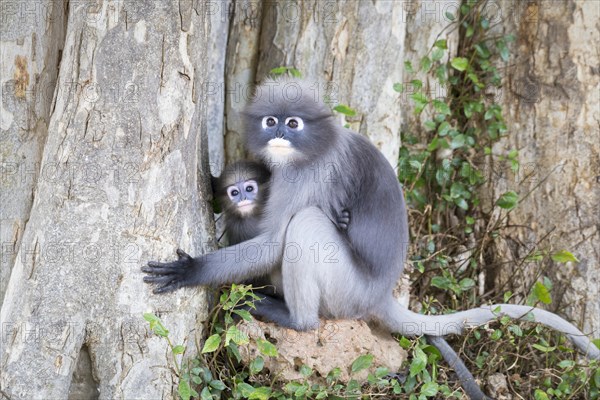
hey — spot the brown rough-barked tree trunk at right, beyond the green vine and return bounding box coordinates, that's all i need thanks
[491,1,600,337]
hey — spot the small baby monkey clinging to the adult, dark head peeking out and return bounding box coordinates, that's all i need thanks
[212,160,487,399]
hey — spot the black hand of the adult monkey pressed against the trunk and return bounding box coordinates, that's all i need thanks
[142,249,199,294]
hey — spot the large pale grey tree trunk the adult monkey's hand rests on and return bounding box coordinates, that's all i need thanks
[0,2,213,399]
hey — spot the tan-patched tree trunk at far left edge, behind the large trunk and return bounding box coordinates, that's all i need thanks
[0,0,66,305]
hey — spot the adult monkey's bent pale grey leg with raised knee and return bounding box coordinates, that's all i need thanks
[281,207,373,330]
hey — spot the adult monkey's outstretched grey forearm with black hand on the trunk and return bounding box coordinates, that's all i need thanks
[142,234,283,293]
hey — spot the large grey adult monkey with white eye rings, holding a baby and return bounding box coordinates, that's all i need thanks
[143,79,600,394]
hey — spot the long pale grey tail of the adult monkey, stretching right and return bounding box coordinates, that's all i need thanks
[380,298,600,359]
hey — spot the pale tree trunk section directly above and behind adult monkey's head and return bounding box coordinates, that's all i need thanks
[256,0,406,168]
